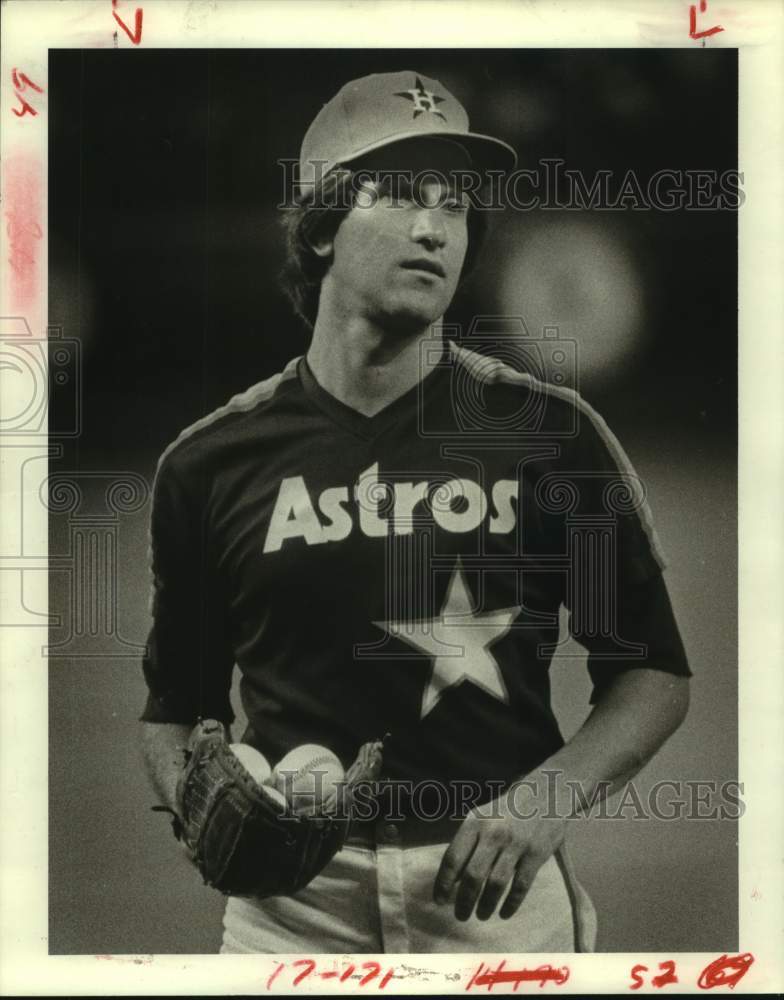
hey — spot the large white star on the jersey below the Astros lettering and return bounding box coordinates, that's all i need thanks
[373,560,522,719]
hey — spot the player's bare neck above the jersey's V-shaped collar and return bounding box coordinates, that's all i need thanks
[307,315,438,417]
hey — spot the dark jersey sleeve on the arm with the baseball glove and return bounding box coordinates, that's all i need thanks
[140,459,234,725]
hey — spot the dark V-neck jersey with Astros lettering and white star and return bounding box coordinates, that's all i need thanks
[142,345,689,796]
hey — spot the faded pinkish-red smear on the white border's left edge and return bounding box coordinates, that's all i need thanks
[3,156,43,313]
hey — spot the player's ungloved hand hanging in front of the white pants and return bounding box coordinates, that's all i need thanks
[433,785,565,920]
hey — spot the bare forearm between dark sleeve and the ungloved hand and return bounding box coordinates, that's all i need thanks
[525,668,689,816]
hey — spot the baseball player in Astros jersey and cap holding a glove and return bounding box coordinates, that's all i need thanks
[142,72,690,954]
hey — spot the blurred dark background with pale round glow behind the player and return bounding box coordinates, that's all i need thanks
[49,49,738,953]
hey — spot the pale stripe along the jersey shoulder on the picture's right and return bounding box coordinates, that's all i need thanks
[449,341,667,569]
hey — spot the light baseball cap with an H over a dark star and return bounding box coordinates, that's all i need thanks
[299,70,517,199]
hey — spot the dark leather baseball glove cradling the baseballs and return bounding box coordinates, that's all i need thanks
[168,719,382,898]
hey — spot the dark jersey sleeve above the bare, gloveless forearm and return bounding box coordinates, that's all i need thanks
[565,390,691,702]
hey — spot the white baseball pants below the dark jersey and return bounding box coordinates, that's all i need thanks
[221,843,596,954]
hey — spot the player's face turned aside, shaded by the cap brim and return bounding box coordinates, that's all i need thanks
[325,140,469,332]
